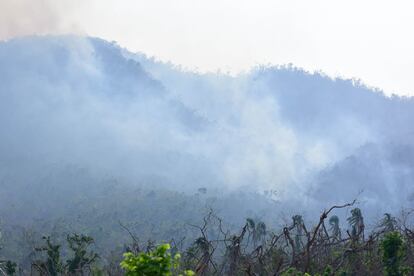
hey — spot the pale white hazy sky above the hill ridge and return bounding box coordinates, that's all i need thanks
[0,0,414,95]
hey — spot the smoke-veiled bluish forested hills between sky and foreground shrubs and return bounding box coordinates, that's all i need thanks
[0,35,414,274]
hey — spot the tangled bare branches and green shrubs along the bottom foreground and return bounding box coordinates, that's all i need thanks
[0,202,414,276]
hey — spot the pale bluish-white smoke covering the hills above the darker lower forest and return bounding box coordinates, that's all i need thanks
[0,36,414,222]
